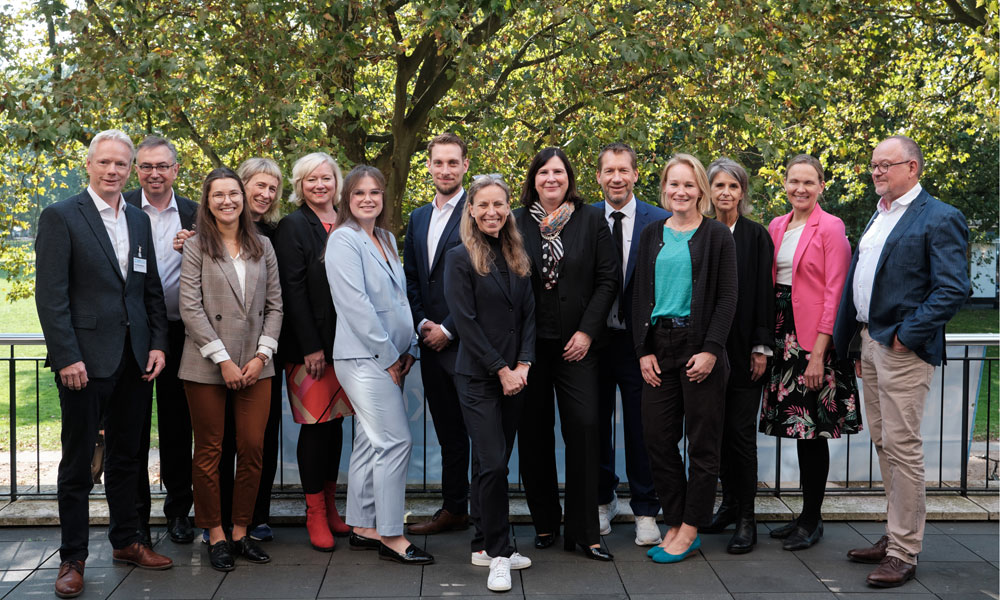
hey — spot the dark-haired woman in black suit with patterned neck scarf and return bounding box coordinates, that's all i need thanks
[514,148,621,560]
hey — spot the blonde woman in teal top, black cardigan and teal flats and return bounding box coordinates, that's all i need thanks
[632,154,737,563]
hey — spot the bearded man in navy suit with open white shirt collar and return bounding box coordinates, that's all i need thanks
[403,133,469,535]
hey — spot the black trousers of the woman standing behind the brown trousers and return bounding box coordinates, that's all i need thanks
[219,363,284,529]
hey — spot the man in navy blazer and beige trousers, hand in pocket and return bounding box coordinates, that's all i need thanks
[833,136,970,587]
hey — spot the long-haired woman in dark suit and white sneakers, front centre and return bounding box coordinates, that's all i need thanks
[445,175,535,592]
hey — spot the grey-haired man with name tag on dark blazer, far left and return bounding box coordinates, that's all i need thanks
[35,130,173,598]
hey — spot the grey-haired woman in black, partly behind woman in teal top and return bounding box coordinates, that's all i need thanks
[702,158,774,554]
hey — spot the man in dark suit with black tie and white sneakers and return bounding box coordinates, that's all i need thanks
[595,142,670,546]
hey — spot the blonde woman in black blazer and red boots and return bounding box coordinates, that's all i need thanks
[275,152,350,552]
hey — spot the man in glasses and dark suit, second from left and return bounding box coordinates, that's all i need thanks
[125,135,198,545]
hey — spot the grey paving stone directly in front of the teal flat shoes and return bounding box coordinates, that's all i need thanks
[617,558,727,598]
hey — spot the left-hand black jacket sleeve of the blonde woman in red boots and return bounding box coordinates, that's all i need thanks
[274,213,320,363]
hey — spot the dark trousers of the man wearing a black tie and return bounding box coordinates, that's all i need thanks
[597,329,660,517]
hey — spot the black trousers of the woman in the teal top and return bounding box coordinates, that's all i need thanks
[642,327,729,527]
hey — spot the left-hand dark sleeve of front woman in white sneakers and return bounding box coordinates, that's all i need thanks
[444,246,508,374]
